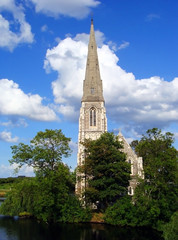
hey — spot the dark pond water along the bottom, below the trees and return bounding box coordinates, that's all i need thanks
[0,216,162,240]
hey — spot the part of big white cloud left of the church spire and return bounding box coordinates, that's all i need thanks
[44,38,87,117]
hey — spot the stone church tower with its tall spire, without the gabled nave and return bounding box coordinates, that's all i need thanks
[76,19,107,194]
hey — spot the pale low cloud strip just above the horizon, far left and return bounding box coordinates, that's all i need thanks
[0,163,34,178]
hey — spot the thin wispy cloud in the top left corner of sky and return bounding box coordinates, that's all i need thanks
[0,0,34,51]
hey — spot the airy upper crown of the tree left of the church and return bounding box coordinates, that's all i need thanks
[10,129,70,174]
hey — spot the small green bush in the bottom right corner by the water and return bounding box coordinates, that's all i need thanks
[163,211,178,240]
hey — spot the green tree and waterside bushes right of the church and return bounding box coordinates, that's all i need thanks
[105,128,177,230]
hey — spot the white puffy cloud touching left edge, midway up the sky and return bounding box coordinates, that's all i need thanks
[0,79,57,121]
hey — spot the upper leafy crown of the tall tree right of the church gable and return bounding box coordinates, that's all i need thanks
[135,128,178,189]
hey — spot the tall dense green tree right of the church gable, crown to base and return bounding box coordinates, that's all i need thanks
[134,128,178,227]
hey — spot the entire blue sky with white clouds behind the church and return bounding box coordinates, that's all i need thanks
[0,0,178,177]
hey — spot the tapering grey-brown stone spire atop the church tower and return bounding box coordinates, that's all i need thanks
[82,19,104,102]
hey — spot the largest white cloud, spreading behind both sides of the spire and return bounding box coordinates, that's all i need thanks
[44,30,178,132]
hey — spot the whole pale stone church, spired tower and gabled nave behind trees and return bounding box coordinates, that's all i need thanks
[76,19,144,195]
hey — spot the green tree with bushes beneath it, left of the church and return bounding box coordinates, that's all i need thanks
[0,130,91,222]
